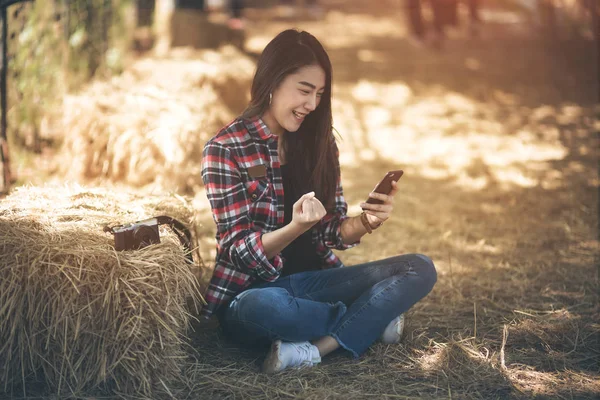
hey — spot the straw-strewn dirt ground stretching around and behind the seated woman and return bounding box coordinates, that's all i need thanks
[5,0,600,400]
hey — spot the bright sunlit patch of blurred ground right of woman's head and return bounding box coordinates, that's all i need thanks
[333,80,572,191]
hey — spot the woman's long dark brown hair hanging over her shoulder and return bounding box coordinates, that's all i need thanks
[242,29,339,211]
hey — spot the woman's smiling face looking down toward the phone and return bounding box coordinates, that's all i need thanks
[262,65,325,135]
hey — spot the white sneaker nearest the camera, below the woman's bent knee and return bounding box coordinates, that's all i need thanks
[262,340,321,374]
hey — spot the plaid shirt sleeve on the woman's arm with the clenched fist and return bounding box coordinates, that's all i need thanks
[202,141,283,281]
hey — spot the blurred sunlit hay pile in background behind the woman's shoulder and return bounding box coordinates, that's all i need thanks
[58,46,254,193]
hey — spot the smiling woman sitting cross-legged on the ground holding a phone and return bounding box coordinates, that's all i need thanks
[202,30,436,373]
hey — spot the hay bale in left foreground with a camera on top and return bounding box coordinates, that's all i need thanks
[0,187,201,398]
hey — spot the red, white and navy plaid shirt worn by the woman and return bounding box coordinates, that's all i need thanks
[202,118,358,318]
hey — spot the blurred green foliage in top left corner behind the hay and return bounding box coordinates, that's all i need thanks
[8,0,130,150]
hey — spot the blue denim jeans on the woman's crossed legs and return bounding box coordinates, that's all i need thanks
[219,254,437,357]
